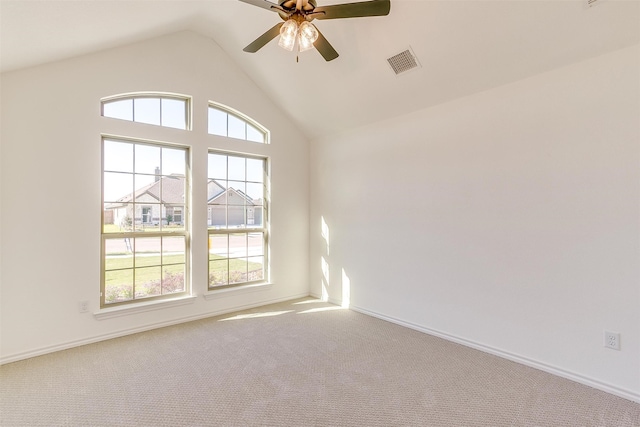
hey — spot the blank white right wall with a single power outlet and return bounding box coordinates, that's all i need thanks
[310,46,640,401]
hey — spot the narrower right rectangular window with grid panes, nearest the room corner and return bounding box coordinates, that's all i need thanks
[207,151,268,289]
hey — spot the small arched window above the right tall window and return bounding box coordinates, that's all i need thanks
[209,103,269,144]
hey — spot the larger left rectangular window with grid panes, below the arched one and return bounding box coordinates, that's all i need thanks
[100,138,189,308]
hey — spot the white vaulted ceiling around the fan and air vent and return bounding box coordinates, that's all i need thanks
[0,0,640,138]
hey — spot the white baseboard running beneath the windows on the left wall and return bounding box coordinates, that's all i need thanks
[0,292,309,365]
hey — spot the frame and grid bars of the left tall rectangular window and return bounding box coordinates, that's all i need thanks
[100,134,191,310]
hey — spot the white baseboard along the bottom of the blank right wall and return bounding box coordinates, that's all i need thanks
[349,305,640,403]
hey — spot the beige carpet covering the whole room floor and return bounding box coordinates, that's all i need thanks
[0,299,640,427]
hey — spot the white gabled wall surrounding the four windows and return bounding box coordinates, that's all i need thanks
[0,32,309,362]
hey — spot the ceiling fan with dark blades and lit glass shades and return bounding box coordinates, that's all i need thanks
[240,0,391,61]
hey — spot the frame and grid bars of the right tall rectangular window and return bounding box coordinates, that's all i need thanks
[206,148,271,292]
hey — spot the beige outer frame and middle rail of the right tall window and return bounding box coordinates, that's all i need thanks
[207,148,271,293]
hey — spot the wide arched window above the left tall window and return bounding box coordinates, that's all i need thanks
[102,94,189,129]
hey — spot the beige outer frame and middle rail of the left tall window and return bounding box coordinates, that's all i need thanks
[100,133,192,313]
